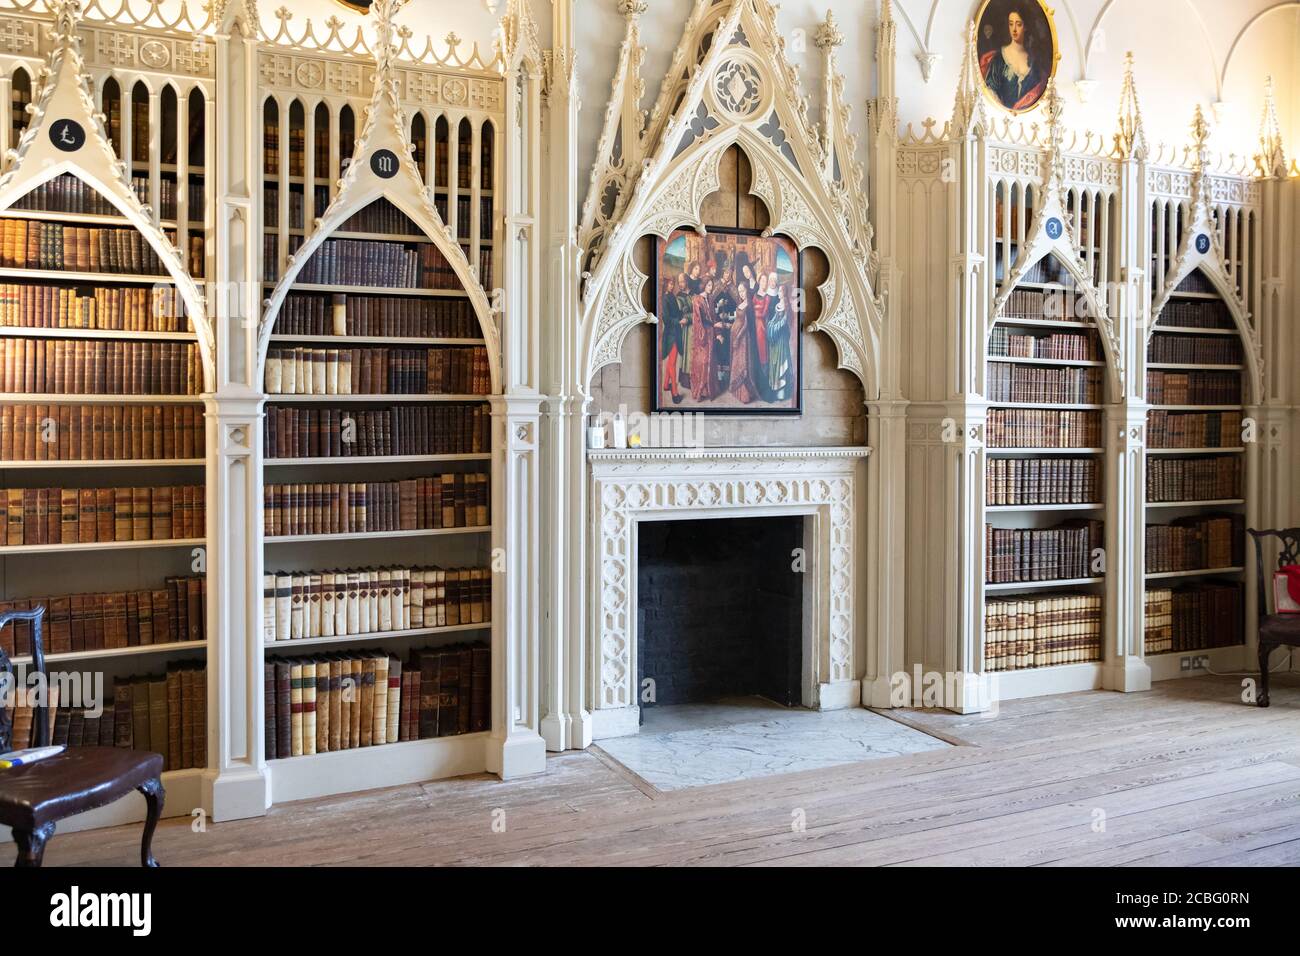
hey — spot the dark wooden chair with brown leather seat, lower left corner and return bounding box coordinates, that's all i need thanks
[0,607,165,866]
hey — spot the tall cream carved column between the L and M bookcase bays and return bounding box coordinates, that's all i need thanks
[204,0,270,821]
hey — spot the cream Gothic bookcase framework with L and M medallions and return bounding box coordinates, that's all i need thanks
[0,0,545,825]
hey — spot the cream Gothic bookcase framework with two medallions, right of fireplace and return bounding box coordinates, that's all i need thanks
[897,27,1294,710]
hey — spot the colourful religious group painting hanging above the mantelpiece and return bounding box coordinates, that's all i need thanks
[654,229,802,415]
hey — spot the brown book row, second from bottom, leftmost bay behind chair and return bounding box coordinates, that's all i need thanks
[0,578,208,657]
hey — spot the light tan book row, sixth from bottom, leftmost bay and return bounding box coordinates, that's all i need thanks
[0,282,190,332]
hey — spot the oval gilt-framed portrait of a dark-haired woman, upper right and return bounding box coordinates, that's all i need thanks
[975,0,1060,113]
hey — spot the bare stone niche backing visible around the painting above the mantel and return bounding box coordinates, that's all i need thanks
[589,143,867,446]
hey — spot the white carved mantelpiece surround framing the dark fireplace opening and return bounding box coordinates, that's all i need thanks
[588,446,871,739]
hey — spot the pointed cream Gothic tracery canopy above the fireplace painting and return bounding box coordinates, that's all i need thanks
[579,0,892,398]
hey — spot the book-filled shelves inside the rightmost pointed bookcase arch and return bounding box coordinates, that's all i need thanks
[1143,272,1251,680]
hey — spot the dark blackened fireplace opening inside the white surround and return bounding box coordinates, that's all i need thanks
[637,516,806,714]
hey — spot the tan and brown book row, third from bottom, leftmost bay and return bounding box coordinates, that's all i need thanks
[0,485,207,548]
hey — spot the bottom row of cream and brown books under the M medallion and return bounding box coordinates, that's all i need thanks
[263,644,491,760]
